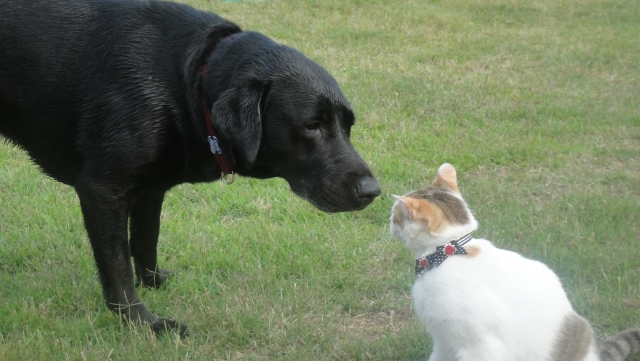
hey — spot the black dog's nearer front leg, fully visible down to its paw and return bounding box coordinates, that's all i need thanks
[75,176,186,334]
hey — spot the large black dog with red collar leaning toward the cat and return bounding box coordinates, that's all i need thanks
[0,0,380,332]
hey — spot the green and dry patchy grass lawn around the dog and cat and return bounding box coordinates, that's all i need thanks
[0,0,640,360]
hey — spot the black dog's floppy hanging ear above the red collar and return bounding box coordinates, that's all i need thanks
[211,80,269,168]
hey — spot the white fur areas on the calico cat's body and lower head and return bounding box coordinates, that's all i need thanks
[390,197,598,361]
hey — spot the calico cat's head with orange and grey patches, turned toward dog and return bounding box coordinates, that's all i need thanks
[389,163,478,256]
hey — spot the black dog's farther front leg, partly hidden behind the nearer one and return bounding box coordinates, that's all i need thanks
[129,190,169,288]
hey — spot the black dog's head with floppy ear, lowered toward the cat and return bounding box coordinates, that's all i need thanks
[203,32,380,212]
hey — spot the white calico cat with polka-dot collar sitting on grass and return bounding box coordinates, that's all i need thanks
[389,163,640,361]
